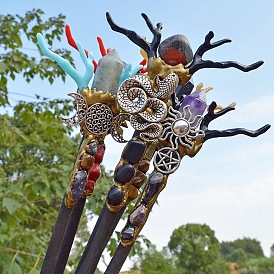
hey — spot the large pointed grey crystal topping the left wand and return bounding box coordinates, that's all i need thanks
[92,49,124,95]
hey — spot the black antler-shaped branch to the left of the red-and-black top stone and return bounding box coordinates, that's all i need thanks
[106,12,163,58]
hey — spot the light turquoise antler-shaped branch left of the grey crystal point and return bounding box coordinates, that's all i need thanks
[37,33,94,91]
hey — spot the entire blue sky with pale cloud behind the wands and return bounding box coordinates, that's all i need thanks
[1,0,274,270]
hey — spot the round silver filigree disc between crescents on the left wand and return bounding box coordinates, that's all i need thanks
[85,103,113,135]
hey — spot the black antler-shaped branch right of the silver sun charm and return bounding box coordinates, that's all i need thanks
[201,101,270,142]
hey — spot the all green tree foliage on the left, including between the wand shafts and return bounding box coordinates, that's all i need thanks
[0,9,150,274]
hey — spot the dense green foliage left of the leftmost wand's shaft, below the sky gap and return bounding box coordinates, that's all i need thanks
[0,97,79,273]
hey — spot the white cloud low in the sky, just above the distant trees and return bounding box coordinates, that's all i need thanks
[143,171,274,256]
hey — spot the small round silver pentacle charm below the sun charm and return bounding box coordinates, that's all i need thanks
[153,147,181,174]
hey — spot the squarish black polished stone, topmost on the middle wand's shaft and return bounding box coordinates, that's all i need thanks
[122,140,146,165]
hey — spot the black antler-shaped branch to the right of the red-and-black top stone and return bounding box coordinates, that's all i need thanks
[186,31,264,75]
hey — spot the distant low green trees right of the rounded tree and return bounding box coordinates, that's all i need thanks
[220,238,264,262]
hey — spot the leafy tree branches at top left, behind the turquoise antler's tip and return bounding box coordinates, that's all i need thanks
[0,9,73,106]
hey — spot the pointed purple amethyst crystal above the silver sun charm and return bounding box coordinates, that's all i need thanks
[179,89,207,117]
